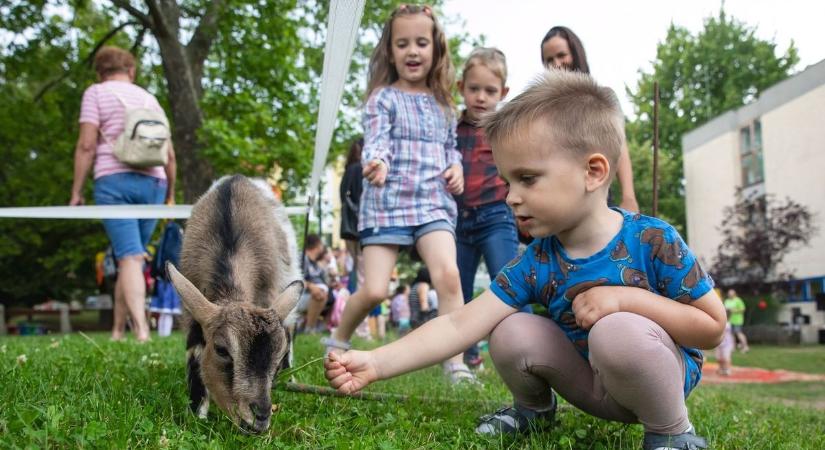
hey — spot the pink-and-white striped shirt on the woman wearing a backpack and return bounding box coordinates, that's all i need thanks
[79,80,166,180]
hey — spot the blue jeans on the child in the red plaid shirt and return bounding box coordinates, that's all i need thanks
[455,202,518,359]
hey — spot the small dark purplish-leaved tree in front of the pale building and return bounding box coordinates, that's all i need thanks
[711,190,818,294]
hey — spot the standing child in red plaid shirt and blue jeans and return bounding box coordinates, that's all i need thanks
[455,48,518,368]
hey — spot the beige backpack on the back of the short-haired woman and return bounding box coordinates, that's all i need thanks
[106,87,171,168]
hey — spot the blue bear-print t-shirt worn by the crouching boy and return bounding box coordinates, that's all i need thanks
[490,208,713,396]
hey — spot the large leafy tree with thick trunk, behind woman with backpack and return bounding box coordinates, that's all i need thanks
[0,0,476,301]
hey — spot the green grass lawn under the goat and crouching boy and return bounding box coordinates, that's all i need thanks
[0,333,825,449]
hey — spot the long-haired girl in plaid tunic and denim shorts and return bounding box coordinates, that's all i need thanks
[324,5,475,383]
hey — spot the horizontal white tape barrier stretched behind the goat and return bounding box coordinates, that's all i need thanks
[0,205,307,219]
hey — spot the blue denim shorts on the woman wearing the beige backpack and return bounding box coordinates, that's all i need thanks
[94,172,167,260]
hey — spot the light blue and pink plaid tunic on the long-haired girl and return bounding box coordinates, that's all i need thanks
[358,86,461,231]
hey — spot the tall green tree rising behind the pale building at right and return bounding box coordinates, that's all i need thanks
[627,10,799,233]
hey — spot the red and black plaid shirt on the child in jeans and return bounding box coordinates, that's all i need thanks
[455,114,507,208]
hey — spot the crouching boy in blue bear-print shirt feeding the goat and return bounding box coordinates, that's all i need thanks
[325,70,725,449]
